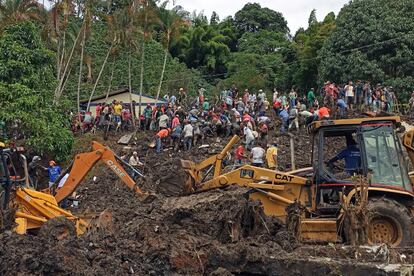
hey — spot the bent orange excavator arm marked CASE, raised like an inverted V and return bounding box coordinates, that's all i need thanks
[55,141,144,203]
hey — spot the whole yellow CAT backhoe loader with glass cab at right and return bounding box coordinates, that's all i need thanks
[181,116,414,246]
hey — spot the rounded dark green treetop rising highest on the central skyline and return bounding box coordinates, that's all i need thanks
[234,3,289,34]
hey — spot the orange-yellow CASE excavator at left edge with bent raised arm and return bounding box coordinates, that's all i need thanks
[0,142,147,235]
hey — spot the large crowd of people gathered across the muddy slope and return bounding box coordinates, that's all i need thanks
[68,80,414,167]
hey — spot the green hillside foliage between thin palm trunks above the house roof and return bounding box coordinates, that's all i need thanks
[65,22,211,100]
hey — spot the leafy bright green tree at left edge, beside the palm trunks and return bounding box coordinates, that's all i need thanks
[0,21,73,162]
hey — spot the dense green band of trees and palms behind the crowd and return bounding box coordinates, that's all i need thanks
[0,0,414,156]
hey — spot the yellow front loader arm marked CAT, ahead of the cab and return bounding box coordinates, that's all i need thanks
[181,136,312,219]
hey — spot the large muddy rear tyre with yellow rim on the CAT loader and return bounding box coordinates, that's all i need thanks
[367,198,413,247]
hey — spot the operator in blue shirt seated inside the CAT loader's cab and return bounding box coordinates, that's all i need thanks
[328,136,361,175]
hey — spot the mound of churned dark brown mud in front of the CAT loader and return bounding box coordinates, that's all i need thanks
[0,189,283,275]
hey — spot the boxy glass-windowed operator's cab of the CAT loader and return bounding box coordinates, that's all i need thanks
[313,117,413,213]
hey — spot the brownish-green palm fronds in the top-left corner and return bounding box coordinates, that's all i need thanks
[0,0,44,29]
